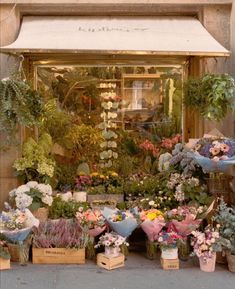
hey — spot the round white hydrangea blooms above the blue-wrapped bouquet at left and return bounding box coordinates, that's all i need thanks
[9,181,53,210]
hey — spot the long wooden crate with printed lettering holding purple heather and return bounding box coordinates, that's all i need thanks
[33,248,85,264]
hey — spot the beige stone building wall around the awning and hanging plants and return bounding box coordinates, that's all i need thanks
[0,0,235,207]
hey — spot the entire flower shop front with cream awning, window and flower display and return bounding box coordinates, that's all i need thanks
[0,16,235,272]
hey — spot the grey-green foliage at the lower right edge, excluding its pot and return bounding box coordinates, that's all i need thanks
[214,200,235,255]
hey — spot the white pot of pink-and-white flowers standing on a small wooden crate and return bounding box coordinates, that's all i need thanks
[95,232,129,257]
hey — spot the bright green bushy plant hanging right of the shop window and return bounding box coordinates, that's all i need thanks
[184,74,235,121]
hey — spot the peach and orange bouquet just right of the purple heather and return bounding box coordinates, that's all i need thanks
[76,209,106,237]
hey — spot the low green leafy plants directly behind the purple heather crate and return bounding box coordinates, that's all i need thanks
[49,196,89,219]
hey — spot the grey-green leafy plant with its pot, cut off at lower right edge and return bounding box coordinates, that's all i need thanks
[214,200,235,273]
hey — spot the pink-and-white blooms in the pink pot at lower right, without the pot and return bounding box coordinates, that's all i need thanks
[191,226,222,262]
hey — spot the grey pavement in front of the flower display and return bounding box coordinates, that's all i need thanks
[0,253,235,289]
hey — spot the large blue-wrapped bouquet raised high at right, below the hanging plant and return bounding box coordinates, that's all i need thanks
[192,136,235,175]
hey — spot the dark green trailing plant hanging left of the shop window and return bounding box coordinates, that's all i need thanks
[0,76,44,149]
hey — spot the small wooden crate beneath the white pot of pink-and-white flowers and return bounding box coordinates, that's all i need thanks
[97,253,125,270]
